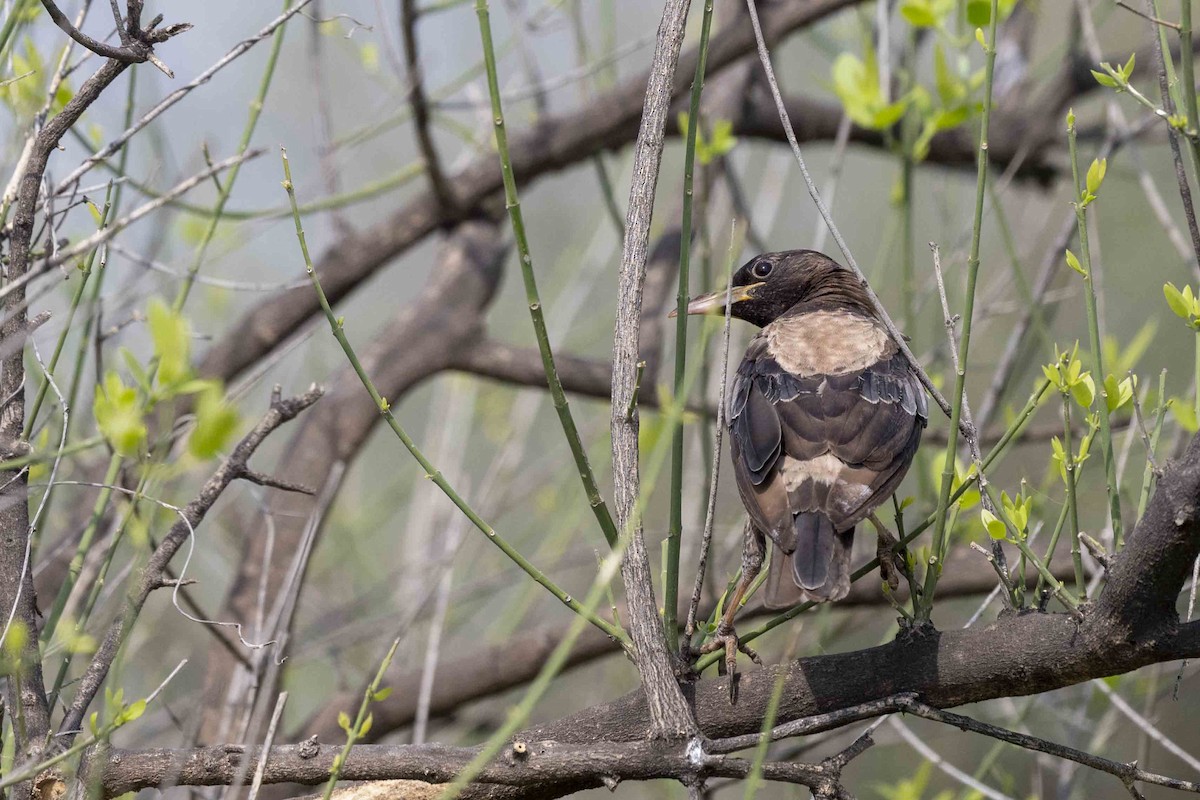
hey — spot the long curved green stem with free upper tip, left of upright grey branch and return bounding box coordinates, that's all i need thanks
[280,148,631,648]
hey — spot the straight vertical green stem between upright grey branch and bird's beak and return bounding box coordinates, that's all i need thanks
[662,0,713,652]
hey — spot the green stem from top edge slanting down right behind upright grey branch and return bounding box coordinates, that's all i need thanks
[475,0,617,547]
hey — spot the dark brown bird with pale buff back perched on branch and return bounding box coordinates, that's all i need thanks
[686,249,929,692]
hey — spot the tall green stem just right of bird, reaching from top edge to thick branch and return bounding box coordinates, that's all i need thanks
[919,0,1000,621]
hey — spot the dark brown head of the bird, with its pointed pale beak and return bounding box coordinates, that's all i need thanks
[671,249,875,327]
